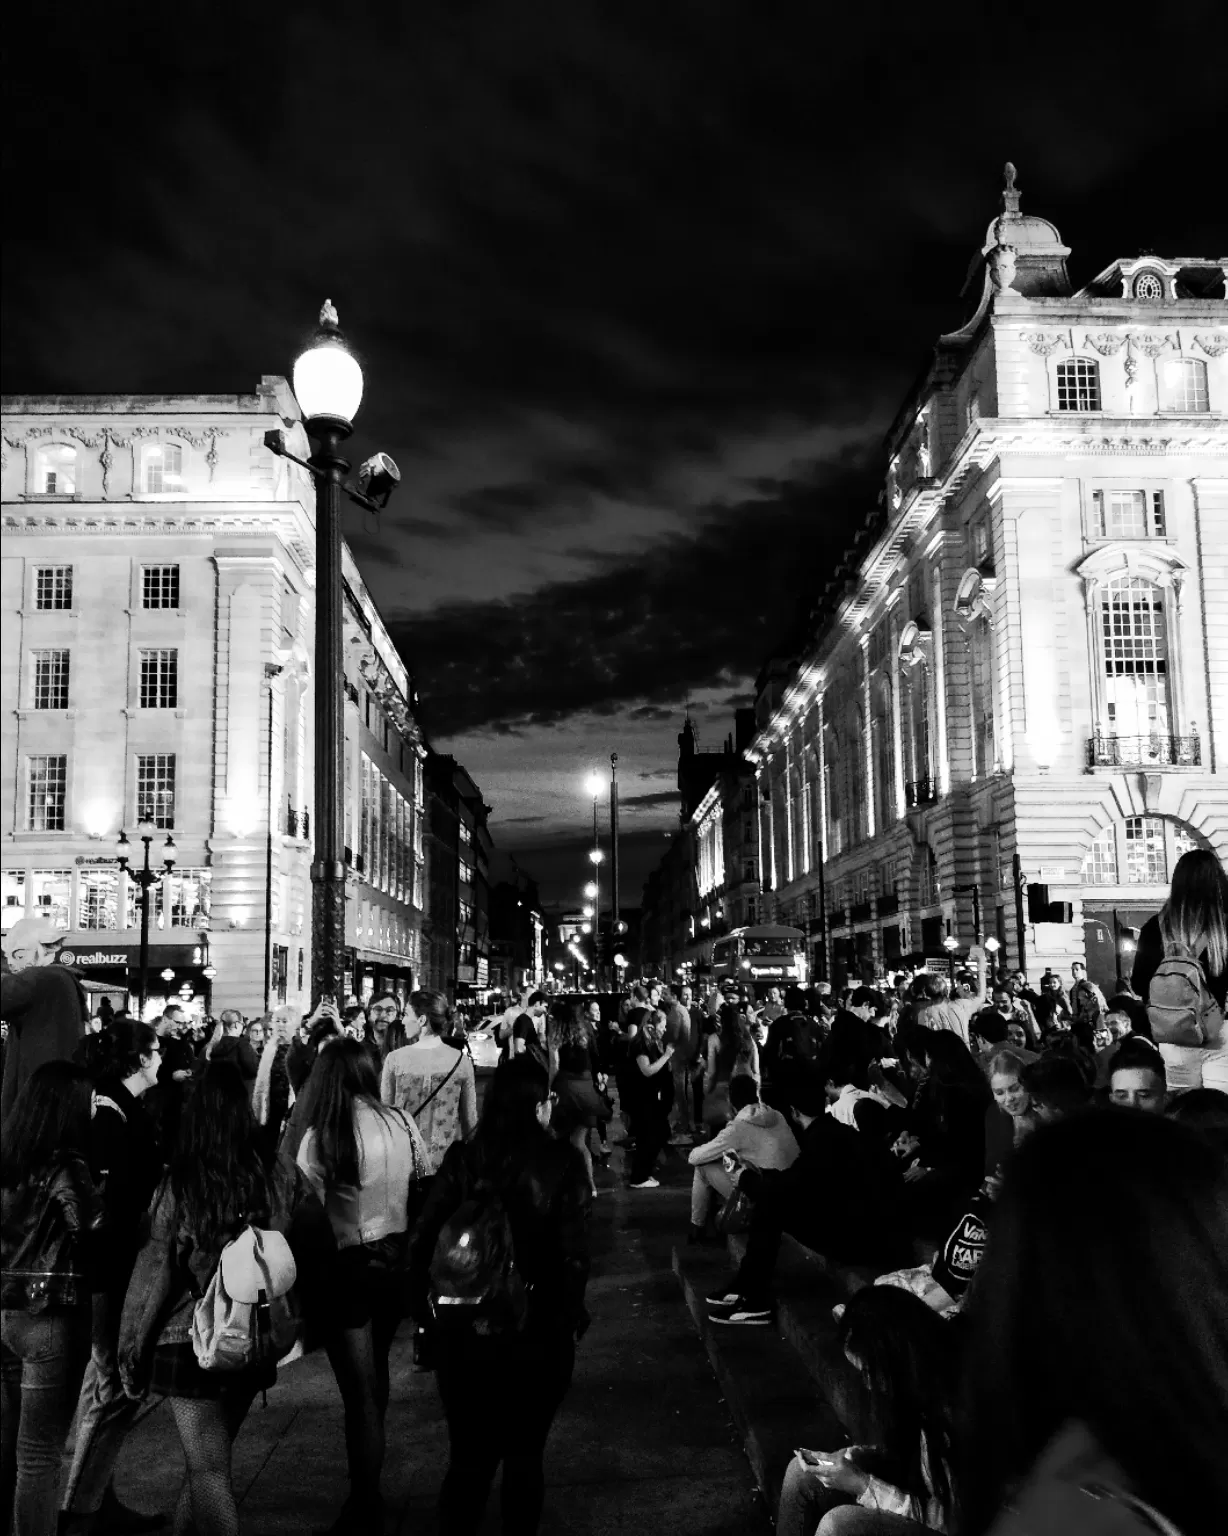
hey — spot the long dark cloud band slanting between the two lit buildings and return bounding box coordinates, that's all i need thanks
[393,448,873,736]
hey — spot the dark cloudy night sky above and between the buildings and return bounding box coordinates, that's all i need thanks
[3,0,1228,902]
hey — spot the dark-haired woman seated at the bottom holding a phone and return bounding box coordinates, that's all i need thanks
[776,1286,958,1536]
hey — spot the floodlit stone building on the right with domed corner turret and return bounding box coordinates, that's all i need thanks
[748,167,1228,985]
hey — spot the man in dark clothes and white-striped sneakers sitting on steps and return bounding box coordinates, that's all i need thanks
[707,1071,908,1326]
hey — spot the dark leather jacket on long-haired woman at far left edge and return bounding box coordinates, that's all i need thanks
[0,1154,105,1312]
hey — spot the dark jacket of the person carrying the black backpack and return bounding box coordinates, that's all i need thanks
[409,1132,592,1338]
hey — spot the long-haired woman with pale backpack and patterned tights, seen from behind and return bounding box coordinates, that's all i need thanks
[118,1061,337,1536]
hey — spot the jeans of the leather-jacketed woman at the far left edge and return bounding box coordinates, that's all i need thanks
[0,1309,89,1536]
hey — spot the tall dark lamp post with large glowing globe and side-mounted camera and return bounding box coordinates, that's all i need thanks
[264,300,401,1003]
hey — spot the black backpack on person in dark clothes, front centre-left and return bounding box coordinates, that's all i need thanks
[430,1180,529,1335]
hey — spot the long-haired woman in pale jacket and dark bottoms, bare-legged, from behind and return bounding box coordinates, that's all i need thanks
[298,1040,427,1531]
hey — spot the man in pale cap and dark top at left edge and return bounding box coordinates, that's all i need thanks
[0,917,86,1120]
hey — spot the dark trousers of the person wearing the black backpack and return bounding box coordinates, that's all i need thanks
[435,1332,575,1536]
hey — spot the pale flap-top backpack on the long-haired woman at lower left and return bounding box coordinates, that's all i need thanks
[192,1226,300,1370]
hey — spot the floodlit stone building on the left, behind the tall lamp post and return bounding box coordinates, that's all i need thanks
[0,378,426,1012]
